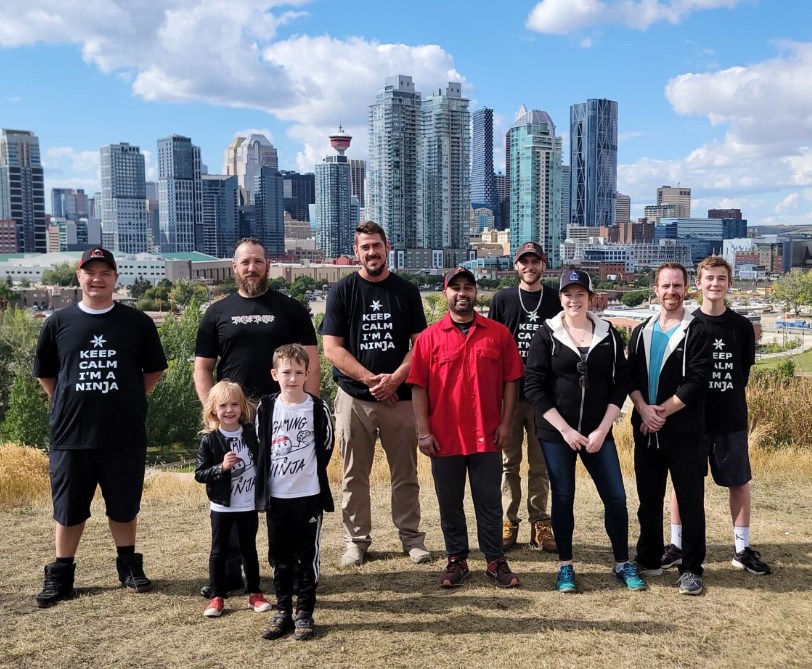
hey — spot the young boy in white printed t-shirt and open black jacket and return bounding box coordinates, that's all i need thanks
[256,344,335,641]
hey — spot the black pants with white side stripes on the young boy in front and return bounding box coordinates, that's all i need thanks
[265,495,323,614]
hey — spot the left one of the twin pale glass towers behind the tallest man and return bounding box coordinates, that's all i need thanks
[366,74,420,254]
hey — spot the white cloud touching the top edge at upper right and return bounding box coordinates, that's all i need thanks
[525,0,741,34]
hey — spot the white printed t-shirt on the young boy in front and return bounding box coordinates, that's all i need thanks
[268,395,319,499]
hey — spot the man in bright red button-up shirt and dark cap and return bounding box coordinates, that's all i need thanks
[406,267,524,588]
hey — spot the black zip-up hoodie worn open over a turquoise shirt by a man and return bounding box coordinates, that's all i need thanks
[629,310,712,447]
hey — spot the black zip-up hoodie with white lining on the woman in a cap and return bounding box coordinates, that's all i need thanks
[524,313,629,442]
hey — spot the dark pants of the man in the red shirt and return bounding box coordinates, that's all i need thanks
[431,452,504,562]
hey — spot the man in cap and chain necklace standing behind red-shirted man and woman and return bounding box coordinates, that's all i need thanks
[488,242,561,553]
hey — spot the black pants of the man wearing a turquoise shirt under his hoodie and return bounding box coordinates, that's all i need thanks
[634,431,706,575]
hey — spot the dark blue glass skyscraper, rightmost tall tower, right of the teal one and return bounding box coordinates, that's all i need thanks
[570,99,617,227]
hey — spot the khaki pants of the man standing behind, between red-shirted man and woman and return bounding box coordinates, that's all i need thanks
[502,400,550,525]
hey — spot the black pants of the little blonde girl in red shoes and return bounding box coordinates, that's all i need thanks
[209,511,260,597]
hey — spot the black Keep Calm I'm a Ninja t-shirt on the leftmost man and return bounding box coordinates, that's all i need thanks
[34,303,166,450]
